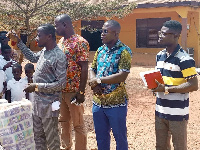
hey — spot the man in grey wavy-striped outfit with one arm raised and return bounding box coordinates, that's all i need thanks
[11,24,67,150]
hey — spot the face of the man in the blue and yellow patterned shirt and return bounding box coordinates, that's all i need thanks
[101,22,118,44]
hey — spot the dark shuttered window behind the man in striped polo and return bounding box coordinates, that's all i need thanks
[136,18,171,48]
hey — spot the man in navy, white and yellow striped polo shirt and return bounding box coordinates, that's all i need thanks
[152,20,198,150]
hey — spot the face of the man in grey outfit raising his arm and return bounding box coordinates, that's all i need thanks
[36,27,49,47]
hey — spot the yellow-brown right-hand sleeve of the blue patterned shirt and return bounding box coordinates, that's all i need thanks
[119,50,131,72]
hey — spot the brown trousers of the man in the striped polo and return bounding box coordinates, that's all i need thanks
[155,116,188,150]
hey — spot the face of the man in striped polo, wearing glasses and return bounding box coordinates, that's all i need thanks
[158,26,176,46]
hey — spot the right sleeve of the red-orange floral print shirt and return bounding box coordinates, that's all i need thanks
[77,41,90,62]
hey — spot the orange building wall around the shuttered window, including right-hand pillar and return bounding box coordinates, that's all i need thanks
[81,6,200,67]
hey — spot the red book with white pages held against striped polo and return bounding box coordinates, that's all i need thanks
[140,70,164,89]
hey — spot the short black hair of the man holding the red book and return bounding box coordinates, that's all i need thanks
[163,20,182,33]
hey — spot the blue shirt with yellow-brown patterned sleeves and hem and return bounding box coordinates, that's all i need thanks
[91,40,132,107]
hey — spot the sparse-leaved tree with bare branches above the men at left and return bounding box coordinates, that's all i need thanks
[0,0,135,62]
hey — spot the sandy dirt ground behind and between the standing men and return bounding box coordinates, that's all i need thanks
[81,66,200,150]
